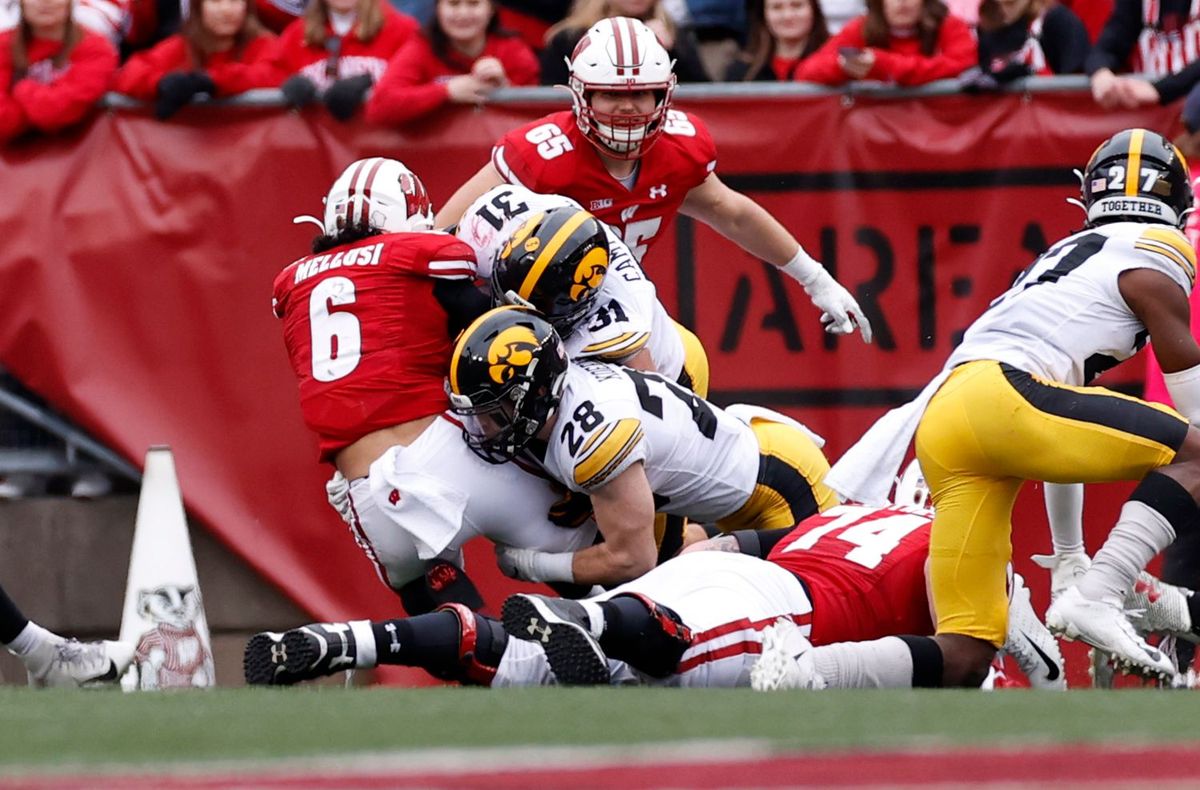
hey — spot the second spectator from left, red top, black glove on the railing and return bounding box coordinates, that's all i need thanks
[113,0,282,118]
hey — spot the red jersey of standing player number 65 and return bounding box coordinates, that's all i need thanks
[492,109,716,261]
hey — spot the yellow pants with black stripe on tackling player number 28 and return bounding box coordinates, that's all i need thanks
[718,417,838,532]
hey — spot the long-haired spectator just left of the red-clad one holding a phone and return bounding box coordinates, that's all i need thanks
[725,0,829,83]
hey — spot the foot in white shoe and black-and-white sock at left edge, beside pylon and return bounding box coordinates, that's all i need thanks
[0,578,133,687]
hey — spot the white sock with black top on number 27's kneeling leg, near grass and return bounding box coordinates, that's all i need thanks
[812,636,942,688]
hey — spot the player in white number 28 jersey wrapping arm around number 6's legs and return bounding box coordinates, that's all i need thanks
[446,306,836,585]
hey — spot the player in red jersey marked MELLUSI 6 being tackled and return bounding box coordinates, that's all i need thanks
[274,157,595,614]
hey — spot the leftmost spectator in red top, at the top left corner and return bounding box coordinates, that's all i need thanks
[0,0,116,142]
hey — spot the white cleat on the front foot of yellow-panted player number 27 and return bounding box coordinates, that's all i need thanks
[1046,587,1175,682]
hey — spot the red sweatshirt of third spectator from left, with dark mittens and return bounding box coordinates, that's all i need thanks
[275,4,418,90]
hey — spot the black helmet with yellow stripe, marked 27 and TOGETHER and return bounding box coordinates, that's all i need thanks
[1082,128,1192,228]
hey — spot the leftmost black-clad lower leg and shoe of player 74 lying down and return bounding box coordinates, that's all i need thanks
[242,604,508,686]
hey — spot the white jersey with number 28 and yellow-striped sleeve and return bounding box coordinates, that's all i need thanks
[544,360,760,523]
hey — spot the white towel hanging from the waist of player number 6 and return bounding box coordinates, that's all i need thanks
[370,461,467,559]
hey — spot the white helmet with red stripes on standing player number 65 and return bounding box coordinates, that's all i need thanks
[568,17,676,158]
